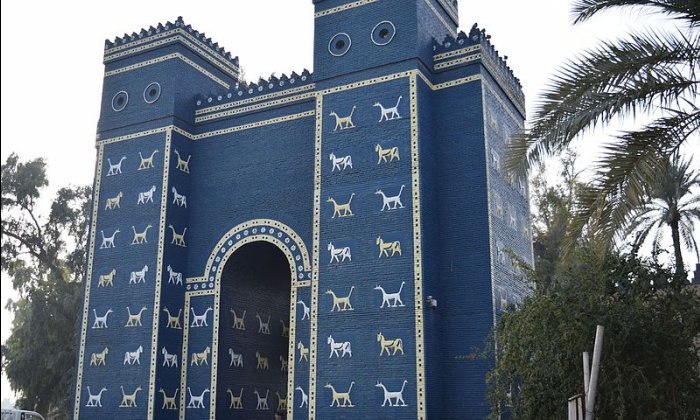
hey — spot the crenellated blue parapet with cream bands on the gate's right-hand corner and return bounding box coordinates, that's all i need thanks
[433,23,525,115]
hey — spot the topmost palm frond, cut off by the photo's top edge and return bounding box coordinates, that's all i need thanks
[572,0,700,26]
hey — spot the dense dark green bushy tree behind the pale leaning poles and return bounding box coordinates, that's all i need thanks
[488,247,700,420]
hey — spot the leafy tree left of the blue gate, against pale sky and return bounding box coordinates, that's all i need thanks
[1,154,92,414]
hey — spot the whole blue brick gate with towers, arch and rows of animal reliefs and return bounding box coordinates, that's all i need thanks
[73,0,532,420]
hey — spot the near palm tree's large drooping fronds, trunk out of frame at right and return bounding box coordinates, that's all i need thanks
[506,0,700,243]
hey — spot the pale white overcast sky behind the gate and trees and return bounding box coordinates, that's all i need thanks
[0,0,700,406]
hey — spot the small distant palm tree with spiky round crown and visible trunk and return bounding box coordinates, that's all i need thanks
[628,155,700,273]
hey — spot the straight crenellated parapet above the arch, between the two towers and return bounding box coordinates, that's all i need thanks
[195,69,315,122]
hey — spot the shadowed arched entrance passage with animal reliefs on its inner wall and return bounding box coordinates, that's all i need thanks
[216,242,291,420]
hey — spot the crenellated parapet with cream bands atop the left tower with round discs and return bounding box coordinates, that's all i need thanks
[104,17,240,79]
